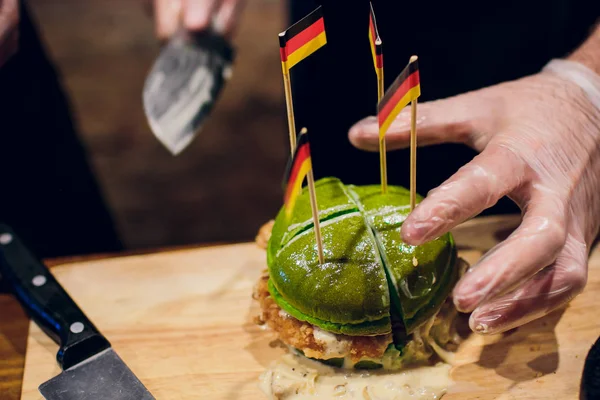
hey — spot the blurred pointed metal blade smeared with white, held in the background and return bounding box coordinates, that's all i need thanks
[143,28,234,155]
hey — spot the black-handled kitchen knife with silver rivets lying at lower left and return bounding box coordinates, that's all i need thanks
[0,224,154,400]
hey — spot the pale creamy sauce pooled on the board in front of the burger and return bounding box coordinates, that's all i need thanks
[260,354,452,400]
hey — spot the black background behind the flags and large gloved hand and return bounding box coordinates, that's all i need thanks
[291,0,600,205]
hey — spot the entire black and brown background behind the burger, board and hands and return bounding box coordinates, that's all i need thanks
[0,0,600,256]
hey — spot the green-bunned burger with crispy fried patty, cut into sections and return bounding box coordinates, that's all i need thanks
[253,178,461,370]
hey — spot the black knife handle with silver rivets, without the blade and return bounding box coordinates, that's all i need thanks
[0,223,110,370]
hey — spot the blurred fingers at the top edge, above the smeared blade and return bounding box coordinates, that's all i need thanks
[154,0,245,39]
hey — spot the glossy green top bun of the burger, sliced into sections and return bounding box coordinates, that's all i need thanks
[267,178,457,336]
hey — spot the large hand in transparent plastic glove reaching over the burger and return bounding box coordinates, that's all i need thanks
[349,68,600,333]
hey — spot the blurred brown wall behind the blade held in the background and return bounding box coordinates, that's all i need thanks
[29,0,287,249]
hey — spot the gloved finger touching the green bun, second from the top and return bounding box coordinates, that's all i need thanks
[401,146,527,245]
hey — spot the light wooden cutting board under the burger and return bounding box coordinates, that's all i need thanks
[22,218,600,400]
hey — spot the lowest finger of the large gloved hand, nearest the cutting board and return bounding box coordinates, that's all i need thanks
[469,231,587,334]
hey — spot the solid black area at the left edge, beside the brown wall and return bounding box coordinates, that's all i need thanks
[0,2,122,257]
